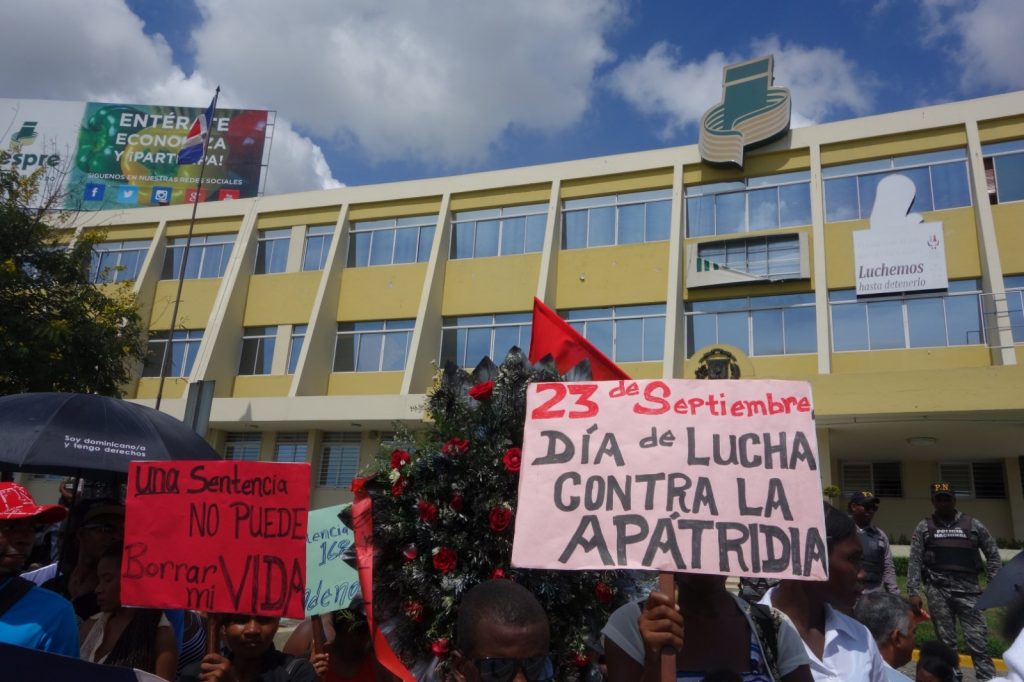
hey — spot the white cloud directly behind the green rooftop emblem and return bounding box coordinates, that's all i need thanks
[608,37,878,138]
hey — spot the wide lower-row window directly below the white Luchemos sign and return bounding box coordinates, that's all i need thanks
[828,280,985,352]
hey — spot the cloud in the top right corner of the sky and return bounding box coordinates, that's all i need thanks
[921,0,1024,92]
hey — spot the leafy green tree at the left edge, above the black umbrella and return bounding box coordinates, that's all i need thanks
[0,169,144,395]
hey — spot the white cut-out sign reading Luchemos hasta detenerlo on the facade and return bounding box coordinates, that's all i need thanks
[853,175,949,296]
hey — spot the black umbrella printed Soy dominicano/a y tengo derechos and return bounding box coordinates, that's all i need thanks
[0,393,221,474]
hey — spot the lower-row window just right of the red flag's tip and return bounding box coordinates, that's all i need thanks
[564,303,665,363]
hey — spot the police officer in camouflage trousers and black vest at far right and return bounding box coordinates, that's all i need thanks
[906,482,1001,682]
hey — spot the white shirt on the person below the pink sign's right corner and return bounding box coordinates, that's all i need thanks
[761,588,887,682]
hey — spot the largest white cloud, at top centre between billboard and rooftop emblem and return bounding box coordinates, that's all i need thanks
[195,0,621,165]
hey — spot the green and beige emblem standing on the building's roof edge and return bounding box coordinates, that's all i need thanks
[697,54,792,167]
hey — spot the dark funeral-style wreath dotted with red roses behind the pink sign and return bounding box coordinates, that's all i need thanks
[353,348,636,680]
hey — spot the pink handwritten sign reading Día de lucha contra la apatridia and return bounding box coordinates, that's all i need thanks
[512,379,827,580]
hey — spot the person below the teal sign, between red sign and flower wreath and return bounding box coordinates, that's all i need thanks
[282,600,377,682]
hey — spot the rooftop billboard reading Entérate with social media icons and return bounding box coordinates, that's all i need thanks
[0,99,269,211]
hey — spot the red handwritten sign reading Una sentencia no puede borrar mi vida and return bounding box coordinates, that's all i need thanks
[121,462,309,619]
